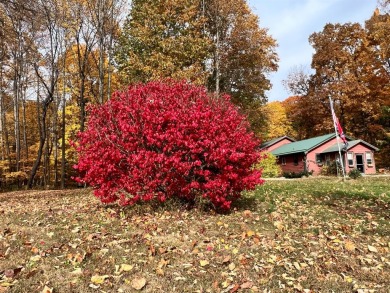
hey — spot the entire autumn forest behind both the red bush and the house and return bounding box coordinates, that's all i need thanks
[0,0,390,189]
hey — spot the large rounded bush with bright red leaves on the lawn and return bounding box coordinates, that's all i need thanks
[75,82,262,210]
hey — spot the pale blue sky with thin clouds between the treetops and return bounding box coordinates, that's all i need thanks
[248,0,377,101]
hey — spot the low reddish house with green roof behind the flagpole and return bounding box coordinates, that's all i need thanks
[262,133,378,175]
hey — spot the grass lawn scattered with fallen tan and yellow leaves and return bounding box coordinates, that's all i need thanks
[0,177,390,293]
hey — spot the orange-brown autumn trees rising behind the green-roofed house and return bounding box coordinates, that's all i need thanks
[262,1,390,168]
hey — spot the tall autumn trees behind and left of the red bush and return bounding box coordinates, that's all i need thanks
[0,0,278,189]
